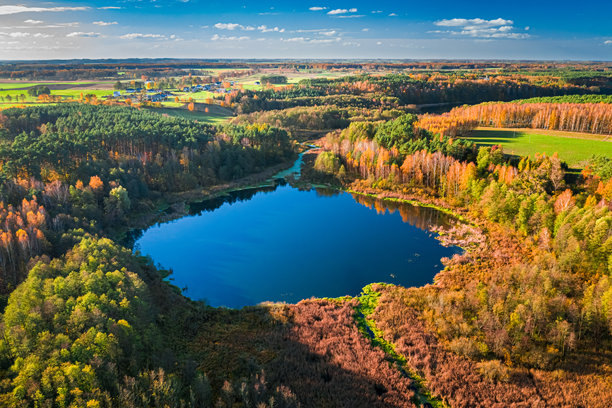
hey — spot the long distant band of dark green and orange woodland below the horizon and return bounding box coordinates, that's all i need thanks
[232,74,599,113]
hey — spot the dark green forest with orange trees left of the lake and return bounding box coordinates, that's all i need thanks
[0,104,294,293]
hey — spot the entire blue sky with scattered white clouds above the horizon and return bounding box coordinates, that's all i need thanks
[0,0,612,61]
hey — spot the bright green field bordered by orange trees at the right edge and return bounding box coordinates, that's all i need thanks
[466,128,612,168]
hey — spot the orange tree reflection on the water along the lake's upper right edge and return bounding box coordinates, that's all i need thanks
[351,194,452,231]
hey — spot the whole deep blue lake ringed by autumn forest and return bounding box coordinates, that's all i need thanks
[135,159,461,308]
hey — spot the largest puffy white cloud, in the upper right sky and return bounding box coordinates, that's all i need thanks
[429,18,530,40]
